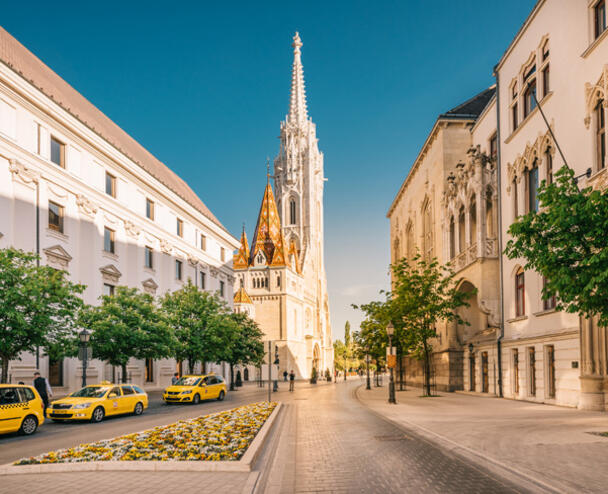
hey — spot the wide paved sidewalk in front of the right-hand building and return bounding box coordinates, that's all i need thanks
[356,385,608,493]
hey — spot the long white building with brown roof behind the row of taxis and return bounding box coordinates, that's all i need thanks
[0,29,238,392]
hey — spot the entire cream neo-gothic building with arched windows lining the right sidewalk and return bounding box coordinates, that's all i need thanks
[388,0,608,410]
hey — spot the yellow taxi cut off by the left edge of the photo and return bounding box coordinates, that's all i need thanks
[0,384,44,436]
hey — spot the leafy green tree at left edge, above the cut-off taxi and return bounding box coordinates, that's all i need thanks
[0,248,85,383]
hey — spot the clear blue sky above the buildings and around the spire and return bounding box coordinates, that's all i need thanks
[2,0,535,338]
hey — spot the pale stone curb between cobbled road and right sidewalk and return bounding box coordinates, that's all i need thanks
[353,384,564,494]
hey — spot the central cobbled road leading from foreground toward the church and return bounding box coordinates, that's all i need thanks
[256,382,525,494]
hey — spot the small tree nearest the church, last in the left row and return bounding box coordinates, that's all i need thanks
[222,313,265,391]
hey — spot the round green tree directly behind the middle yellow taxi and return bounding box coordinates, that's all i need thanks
[81,286,177,382]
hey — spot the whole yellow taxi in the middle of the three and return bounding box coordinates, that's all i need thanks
[47,381,148,422]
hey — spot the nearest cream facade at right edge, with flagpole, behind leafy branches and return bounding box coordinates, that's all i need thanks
[497,0,608,409]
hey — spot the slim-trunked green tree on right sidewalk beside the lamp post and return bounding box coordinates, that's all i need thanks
[387,254,470,396]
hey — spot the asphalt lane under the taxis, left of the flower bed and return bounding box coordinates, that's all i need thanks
[0,385,274,465]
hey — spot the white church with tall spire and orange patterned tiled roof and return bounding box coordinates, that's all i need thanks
[233,33,333,378]
